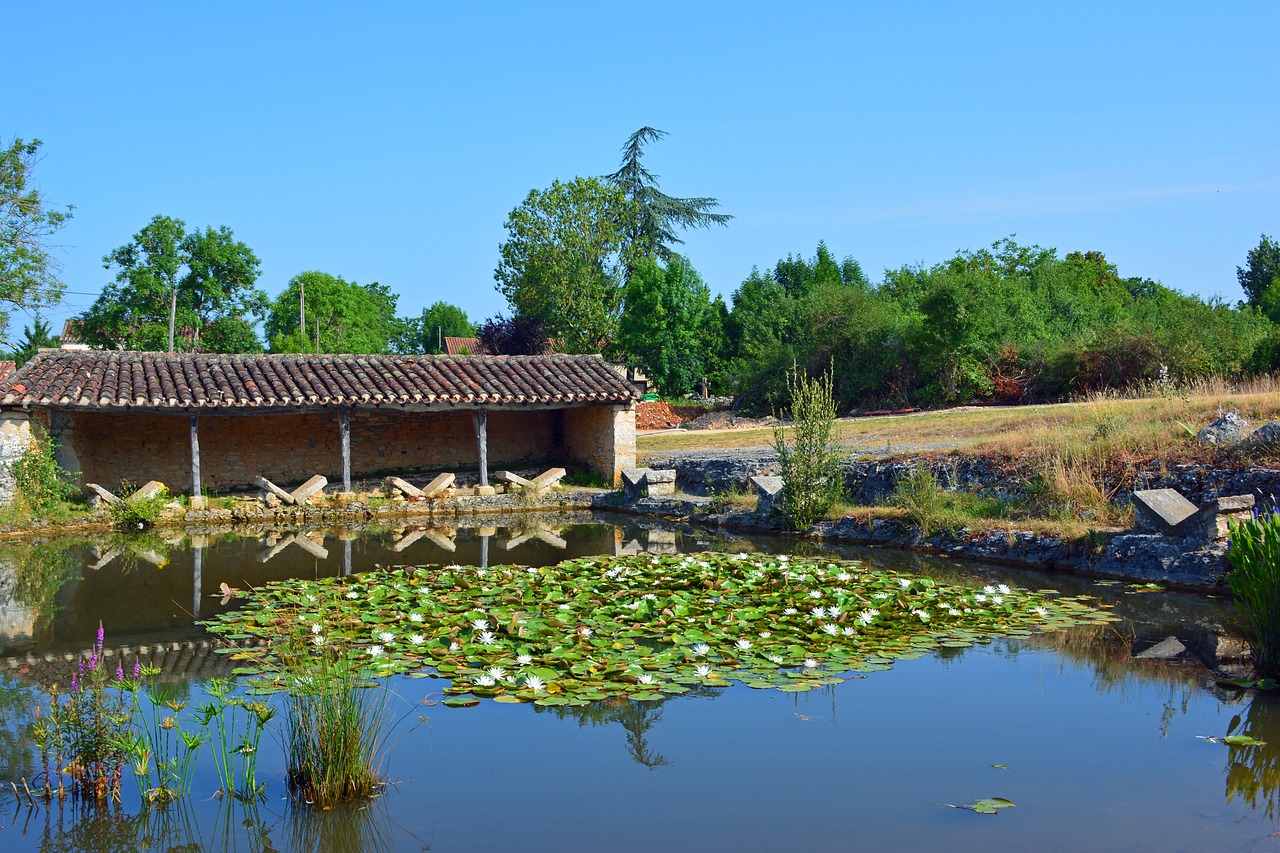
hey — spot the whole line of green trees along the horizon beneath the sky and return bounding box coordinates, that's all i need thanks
[0,134,1280,411]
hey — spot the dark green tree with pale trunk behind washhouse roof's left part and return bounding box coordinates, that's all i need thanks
[77,216,266,352]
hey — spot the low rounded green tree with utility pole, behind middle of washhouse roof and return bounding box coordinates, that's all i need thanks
[265,270,404,355]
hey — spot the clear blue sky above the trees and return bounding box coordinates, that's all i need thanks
[0,0,1280,333]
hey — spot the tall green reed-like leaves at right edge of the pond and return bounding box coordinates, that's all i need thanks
[1226,510,1280,678]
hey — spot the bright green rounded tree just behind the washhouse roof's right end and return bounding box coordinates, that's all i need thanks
[617,256,710,396]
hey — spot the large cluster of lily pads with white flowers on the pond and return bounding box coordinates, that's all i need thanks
[207,553,1115,704]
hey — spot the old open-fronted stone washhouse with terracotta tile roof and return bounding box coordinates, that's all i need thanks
[0,350,637,501]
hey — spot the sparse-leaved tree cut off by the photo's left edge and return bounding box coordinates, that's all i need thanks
[0,140,72,339]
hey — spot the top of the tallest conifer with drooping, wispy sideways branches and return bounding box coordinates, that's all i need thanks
[607,127,733,268]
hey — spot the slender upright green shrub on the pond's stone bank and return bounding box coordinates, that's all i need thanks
[773,368,845,530]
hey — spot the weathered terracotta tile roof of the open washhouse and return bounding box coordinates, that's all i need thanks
[0,350,637,410]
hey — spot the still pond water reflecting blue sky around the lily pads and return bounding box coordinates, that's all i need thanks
[0,515,1280,850]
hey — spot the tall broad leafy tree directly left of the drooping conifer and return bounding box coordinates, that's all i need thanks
[493,178,631,352]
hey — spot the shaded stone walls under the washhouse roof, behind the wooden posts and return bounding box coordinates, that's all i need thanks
[54,406,635,492]
